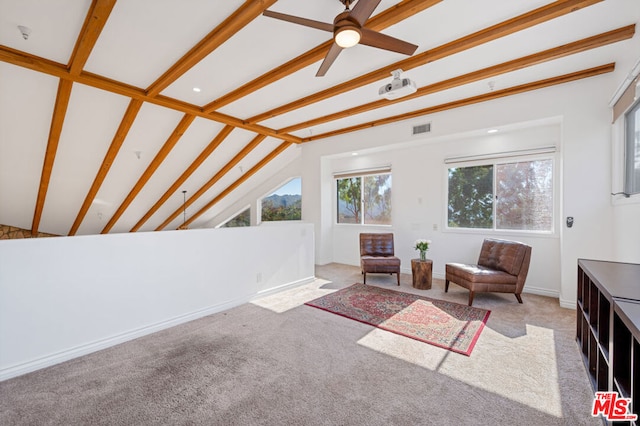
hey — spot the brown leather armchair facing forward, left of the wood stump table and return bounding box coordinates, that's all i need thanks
[360,233,400,285]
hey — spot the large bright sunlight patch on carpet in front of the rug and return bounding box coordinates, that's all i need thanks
[358,324,563,418]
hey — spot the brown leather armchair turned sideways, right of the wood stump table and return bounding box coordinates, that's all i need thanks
[444,238,531,306]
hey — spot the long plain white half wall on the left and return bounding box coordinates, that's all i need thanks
[0,224,314,380]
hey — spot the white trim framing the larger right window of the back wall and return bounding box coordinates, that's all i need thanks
[441,151,561,238]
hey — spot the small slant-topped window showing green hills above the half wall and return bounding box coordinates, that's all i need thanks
[260,178,302,222]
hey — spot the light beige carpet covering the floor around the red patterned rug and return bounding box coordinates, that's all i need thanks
[0,264,601,425]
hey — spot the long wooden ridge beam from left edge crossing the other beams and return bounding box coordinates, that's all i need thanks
[0,46,301,143]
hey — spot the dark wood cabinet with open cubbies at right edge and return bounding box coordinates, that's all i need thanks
[576,259,640,424]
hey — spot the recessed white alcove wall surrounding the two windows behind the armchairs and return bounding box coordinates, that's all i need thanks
[325,119,561,297]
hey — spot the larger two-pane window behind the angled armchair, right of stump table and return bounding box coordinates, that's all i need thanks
[447,159,553,232]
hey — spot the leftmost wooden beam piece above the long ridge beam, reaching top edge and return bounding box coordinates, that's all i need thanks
[69,0,116,75]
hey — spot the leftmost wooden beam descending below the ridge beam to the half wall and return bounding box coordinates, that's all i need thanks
[31,80,73,237]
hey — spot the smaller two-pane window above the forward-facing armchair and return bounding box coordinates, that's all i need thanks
[336,172,391,225]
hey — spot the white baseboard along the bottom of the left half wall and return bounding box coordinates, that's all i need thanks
[0,277,315,382]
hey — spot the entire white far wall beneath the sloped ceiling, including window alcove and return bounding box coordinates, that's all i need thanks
[302,73,640,307]
